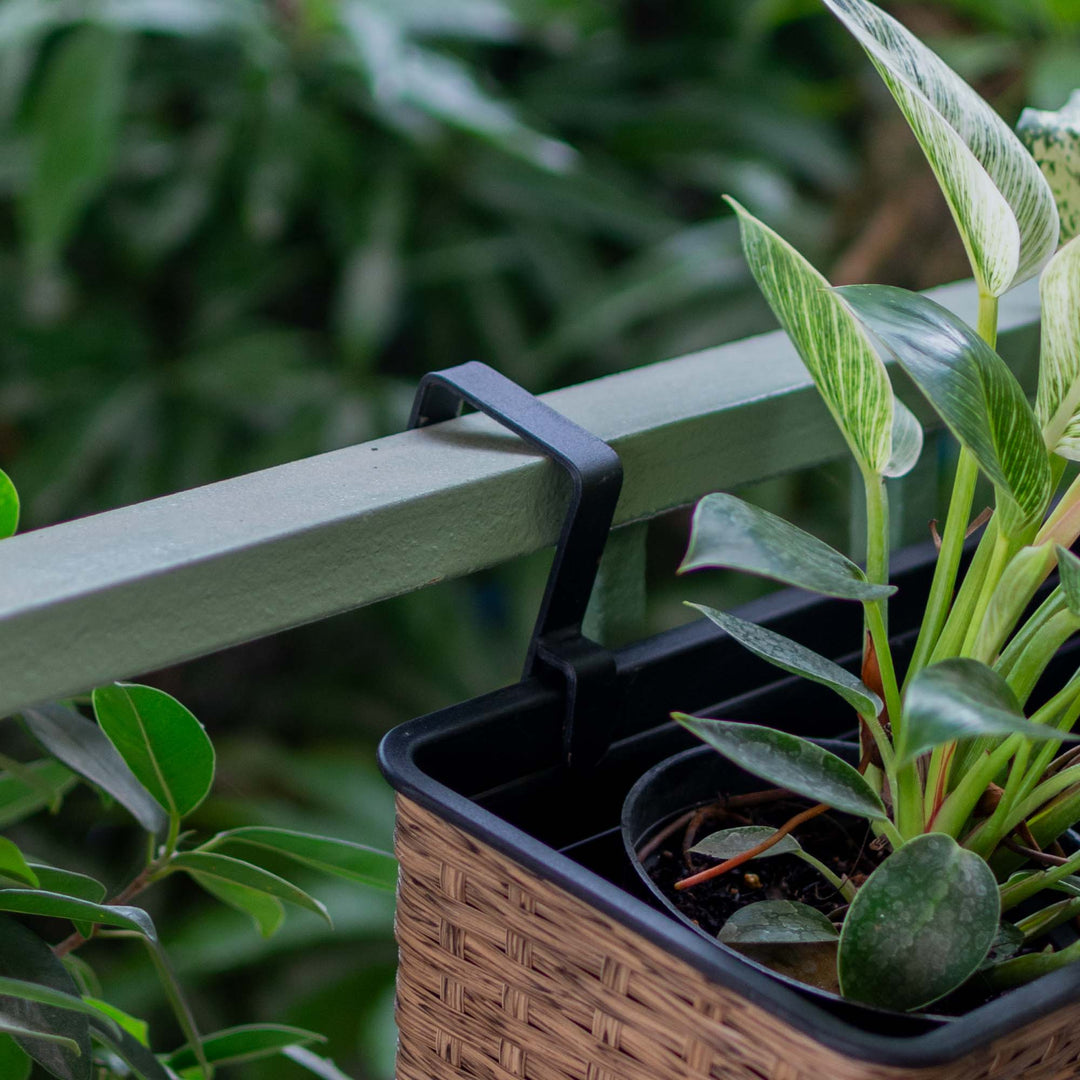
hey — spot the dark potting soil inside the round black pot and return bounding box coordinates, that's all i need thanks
[645,797,885,936]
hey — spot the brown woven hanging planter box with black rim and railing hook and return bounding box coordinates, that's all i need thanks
[380,364,1080,1080]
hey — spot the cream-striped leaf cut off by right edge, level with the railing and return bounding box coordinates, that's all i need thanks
[1035,237,1080,461]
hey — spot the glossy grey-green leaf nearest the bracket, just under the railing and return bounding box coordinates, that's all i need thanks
[678,494,896,600]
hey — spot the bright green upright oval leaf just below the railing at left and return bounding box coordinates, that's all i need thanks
[94,683,214,818]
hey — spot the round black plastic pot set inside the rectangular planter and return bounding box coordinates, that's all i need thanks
[622,739,955,1035]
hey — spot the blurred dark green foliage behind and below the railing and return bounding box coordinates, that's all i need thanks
[0,0,1080,1080]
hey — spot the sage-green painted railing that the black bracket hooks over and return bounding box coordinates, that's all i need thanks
[0,283,1038,716]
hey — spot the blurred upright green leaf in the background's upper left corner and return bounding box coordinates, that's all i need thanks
[21,25,131,267]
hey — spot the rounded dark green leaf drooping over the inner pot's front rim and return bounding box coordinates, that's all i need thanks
[837,833,1001,1011]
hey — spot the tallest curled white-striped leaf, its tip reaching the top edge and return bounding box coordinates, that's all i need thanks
[824,0,1058,296]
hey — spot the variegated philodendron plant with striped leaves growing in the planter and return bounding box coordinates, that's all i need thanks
[676,0,1080,1010]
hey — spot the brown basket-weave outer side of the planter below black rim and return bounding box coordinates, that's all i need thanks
[396,796,1080,1080]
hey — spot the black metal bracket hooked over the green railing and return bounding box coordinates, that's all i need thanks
[409,361,622,768]
